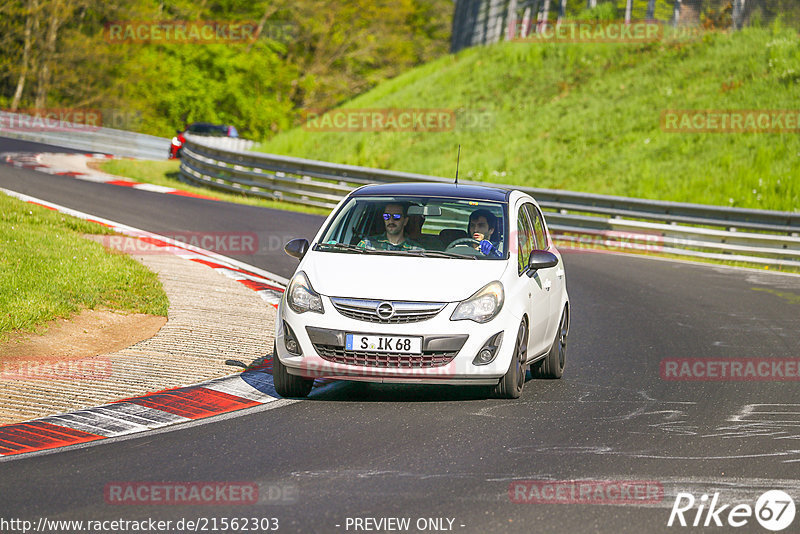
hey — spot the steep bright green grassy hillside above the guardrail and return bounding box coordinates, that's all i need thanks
[255,27,800,211]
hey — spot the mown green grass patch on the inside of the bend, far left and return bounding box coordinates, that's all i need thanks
[0,195,169,340]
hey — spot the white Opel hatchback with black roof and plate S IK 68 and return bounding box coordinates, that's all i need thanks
[273,183,570,398]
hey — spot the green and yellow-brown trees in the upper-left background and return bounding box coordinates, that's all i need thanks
[0,0,452,138]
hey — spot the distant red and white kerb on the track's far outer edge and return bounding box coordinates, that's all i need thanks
[0,152,217,200]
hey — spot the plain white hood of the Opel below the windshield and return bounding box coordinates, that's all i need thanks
[300,251,508,302]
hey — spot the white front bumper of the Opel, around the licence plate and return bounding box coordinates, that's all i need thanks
[275,296,521,385]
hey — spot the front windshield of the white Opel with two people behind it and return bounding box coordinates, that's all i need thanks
[314,196,508,260]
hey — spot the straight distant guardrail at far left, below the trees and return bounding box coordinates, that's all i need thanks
[0,111,170,159]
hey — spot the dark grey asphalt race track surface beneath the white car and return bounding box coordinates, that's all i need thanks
[0,139,800,533]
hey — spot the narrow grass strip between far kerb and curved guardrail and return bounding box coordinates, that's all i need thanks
[98,159,330,215]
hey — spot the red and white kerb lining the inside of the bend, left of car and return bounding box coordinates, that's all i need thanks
[0,188,324,457]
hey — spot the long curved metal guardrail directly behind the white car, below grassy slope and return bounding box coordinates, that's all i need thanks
[181,136,800,267]
